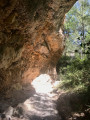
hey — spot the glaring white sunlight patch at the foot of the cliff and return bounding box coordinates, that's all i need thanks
[32,74,53,93]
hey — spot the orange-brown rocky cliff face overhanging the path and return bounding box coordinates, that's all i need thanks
[0,0,76,91]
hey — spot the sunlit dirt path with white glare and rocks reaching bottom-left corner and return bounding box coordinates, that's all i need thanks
[1,75,61,120]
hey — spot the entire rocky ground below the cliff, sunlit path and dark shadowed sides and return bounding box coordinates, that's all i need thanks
[0,74,90,120]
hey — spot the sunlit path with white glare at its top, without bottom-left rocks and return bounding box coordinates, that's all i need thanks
[18,74,60,120]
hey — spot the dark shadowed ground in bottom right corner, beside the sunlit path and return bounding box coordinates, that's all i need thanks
[57,91,90,120]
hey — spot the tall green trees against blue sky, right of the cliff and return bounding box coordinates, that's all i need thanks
[64,0,90,58]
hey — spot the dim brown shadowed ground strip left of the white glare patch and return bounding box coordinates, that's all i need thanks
[0,84,36,113]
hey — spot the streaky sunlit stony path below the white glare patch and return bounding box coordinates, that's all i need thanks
[11,94,61,120]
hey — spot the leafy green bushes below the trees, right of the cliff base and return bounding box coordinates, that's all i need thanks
[59,57,90,90]
